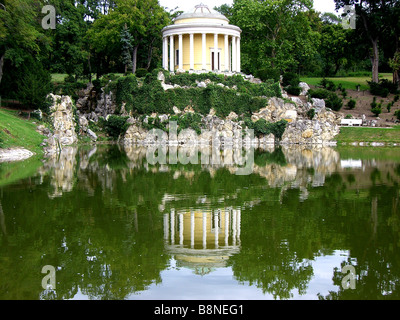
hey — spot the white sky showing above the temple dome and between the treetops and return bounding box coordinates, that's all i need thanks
[159,0,336,13]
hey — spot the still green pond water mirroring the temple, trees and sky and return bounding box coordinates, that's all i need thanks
[0,145,400,300]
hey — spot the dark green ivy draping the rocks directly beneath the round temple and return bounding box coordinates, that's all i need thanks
[108,74,280,117]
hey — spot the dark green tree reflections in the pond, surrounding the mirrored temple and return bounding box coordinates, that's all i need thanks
[0,146,400,299]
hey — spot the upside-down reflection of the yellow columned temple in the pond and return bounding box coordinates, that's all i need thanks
[164,208,241,274]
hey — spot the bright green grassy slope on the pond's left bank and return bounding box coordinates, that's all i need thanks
[0,109,44,154]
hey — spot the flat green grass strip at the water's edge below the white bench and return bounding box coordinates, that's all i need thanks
[336,126,400,144]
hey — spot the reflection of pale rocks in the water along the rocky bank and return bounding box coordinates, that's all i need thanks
[41,146,340,199]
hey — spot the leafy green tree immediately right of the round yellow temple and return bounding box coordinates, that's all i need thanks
[231,0,318,72]
